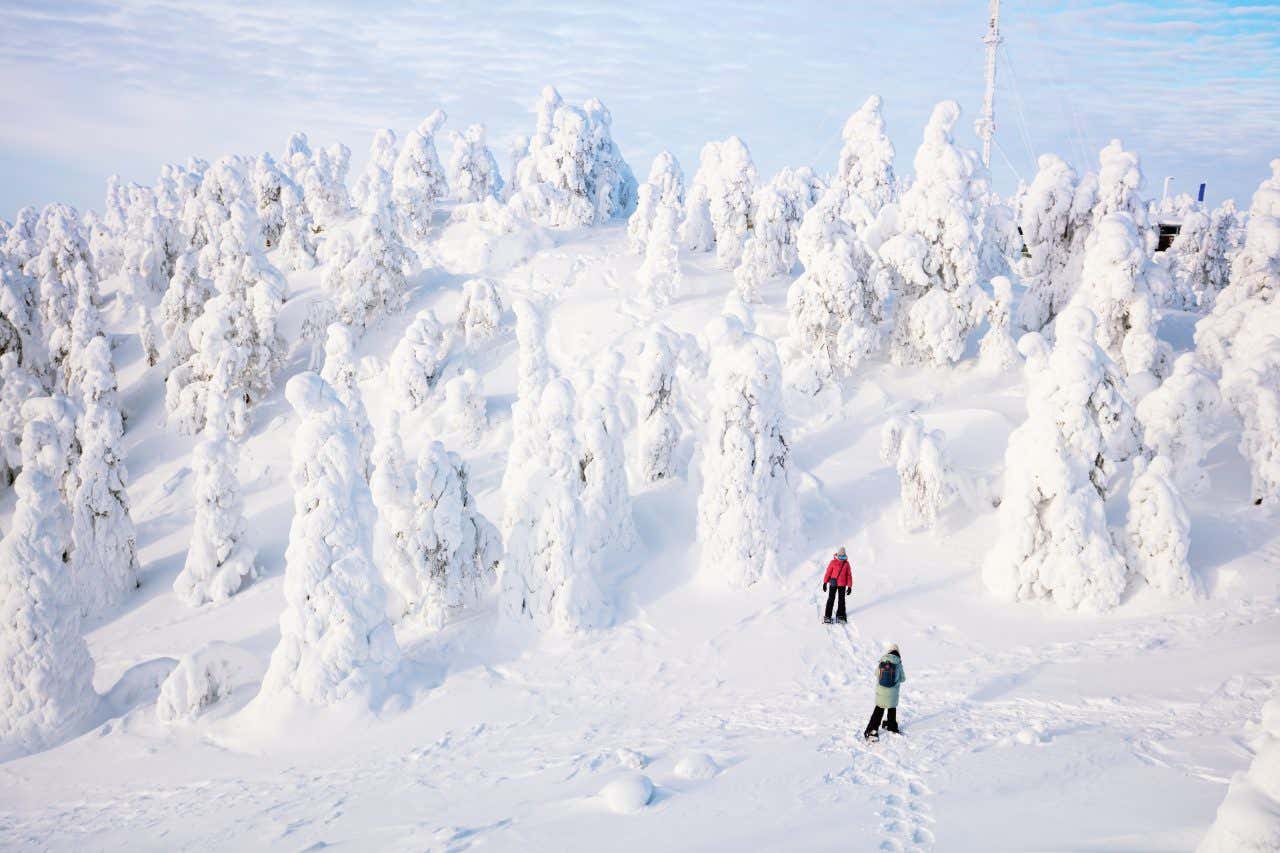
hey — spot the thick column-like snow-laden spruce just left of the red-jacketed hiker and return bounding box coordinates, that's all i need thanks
[698,316,797,585]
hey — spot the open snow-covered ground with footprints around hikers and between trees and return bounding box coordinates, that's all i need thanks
[0,199,1280,850]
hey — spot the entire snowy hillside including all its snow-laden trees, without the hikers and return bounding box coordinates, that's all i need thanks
[0,81,1280,850]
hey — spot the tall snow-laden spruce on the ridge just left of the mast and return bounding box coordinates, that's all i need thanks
[881,101,987,365]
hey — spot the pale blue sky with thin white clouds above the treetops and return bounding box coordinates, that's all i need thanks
[0,0,1280,219]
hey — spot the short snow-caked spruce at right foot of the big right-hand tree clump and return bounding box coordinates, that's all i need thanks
[1124,456,1196,598]
